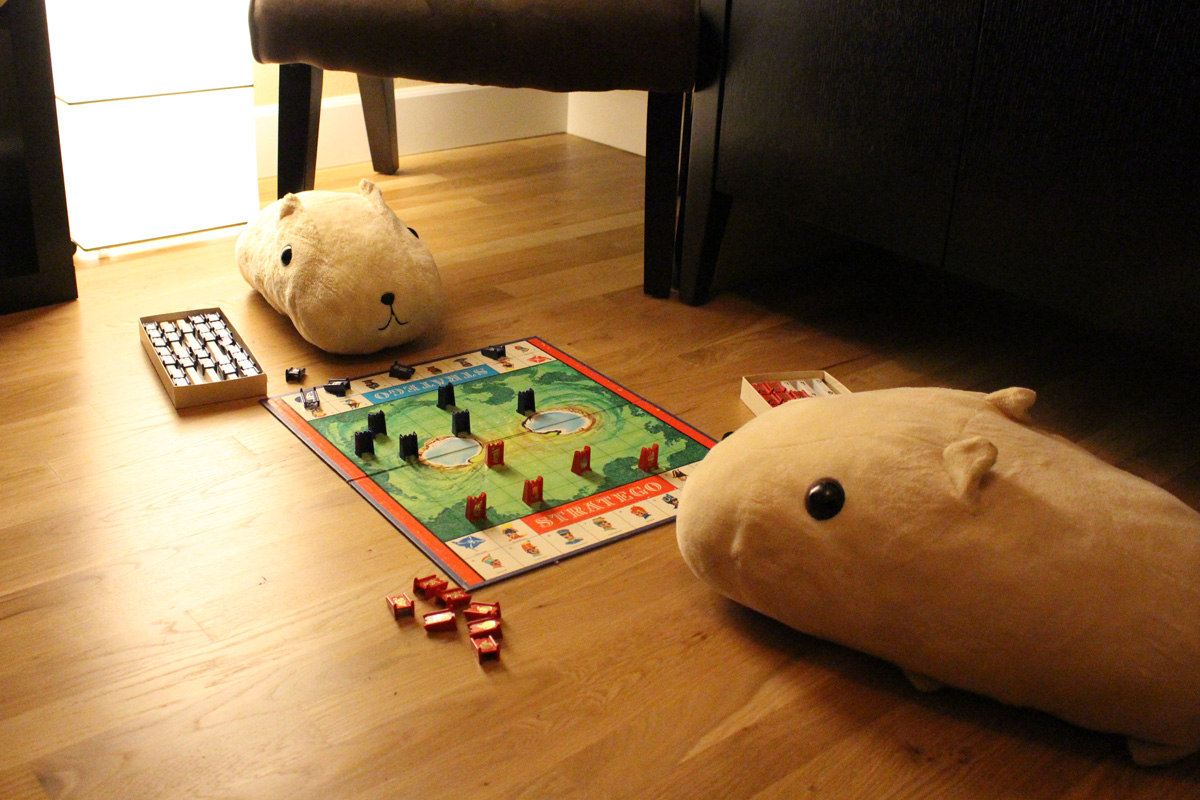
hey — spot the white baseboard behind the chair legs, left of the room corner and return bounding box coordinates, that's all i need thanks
[254,84,566,178]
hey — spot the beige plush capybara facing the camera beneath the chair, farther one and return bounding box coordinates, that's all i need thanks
[236,179,444,353]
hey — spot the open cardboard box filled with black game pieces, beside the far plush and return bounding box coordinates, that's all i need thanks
[138,308,266,408]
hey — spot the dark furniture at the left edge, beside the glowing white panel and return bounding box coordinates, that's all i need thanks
[0,0,76,313]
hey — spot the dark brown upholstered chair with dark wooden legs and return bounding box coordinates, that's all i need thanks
[250,0,700,296]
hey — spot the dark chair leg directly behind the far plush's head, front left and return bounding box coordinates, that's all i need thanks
[275,64,324,197]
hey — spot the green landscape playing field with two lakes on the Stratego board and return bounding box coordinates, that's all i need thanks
[311,361,707,541]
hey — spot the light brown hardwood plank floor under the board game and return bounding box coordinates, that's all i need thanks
[0,136,1200,800]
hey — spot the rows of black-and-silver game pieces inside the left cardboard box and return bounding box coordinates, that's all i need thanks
[143,313,263,386]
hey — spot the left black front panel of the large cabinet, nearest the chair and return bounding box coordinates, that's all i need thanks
[716,0,982,268]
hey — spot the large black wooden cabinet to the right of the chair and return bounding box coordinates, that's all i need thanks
[679,0,1200,347]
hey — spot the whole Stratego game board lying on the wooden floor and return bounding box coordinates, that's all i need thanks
[263,338,715,589]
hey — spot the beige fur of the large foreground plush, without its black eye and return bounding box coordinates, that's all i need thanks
[678,389,1200,764]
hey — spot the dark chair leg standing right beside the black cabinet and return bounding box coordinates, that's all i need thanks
[642,91,684,297]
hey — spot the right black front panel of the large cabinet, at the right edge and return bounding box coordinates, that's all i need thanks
[944,0,1200,347]
